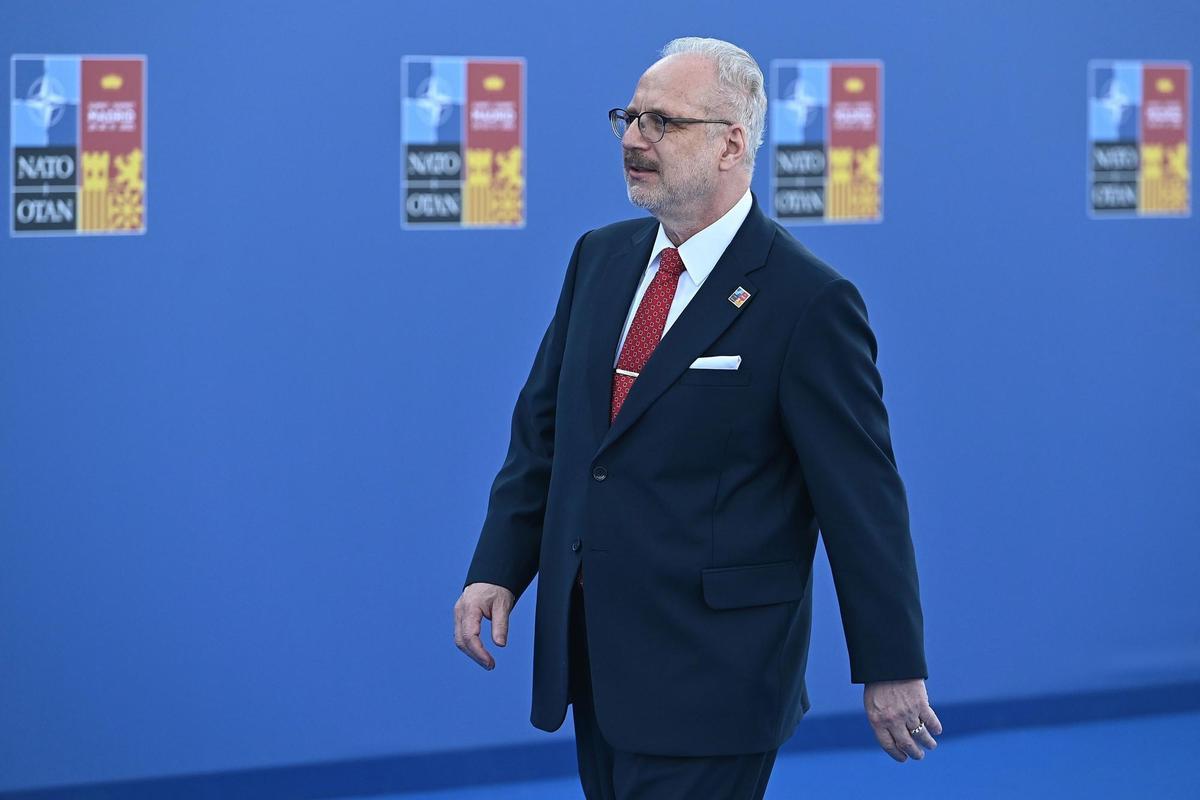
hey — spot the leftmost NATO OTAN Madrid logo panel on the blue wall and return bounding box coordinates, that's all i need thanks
[10,55,146,236]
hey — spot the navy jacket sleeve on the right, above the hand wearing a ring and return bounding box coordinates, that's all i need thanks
[780,279,928,684]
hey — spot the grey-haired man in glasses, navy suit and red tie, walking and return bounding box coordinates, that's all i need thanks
[455,38,941,799]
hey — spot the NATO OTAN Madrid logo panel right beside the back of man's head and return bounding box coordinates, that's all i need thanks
[769,59,883,224]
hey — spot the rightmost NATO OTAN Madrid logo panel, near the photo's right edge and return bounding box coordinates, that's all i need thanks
[1087,61,1192,218]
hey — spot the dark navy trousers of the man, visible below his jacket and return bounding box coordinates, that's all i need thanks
[570,575,779,800]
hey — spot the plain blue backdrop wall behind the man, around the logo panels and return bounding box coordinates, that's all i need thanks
[0,0,1200,789]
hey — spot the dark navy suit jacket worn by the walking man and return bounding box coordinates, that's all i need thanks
[467,194,926,756]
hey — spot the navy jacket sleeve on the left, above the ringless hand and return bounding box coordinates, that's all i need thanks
[466,234,586,597]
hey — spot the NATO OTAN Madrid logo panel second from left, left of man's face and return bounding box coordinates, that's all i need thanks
[401,55,526,228]
